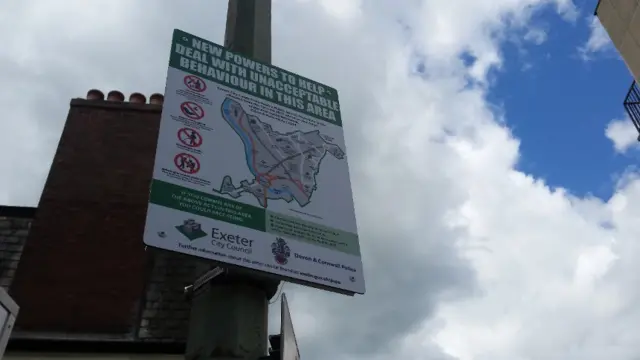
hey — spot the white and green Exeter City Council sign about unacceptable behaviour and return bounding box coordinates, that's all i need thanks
[144,30,365,294]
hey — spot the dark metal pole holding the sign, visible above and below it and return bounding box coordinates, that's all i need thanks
[185,0,279,360]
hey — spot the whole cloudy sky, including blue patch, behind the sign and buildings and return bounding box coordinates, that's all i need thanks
[0,0,640,360]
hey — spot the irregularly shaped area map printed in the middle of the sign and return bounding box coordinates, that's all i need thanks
[214,98,345,208]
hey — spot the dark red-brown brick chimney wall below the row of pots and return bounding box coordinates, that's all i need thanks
[10,99,197,341]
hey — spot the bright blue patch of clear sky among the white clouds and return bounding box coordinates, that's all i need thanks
[489,1,635,199]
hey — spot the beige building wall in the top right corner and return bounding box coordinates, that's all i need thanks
[596,0,640,82]
